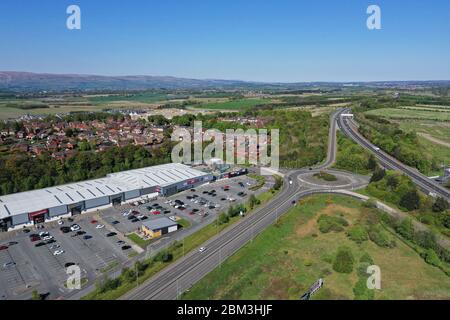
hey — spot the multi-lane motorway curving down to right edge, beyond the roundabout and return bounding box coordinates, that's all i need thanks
[336,109,450,201]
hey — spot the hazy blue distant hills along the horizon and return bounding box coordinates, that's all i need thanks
[0,71,450,92]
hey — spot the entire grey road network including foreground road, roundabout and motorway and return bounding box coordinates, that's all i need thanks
[122,109,449,300]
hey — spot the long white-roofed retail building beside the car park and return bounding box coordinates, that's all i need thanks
[0,163,213,231]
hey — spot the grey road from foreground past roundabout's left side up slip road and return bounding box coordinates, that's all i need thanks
[121,112,356,300]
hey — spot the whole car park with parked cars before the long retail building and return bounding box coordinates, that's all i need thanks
[0,172,264,299]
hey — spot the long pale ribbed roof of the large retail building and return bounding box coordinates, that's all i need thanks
[0,163,206,219]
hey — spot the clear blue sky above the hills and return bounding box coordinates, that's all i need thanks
[0,0,450,82]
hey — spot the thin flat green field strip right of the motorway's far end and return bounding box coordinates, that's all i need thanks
[365,108,450,121]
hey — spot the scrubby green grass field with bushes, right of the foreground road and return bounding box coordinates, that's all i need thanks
[183,195,450,300]
